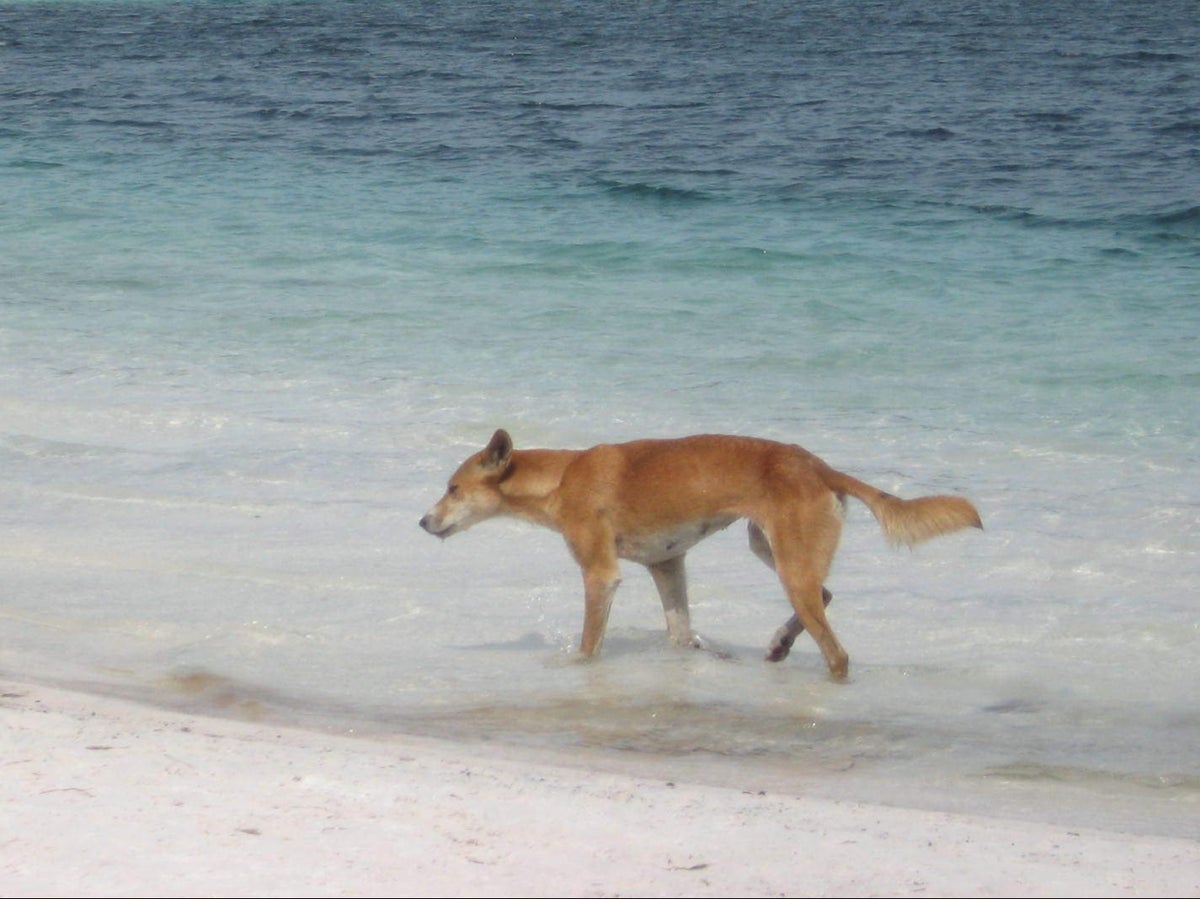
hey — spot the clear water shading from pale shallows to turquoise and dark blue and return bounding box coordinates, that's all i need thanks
[0,0,1200,837]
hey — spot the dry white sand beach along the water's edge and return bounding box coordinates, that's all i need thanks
[0,681,1200,897]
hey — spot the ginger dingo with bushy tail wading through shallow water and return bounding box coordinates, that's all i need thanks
[420,428,983,678]
